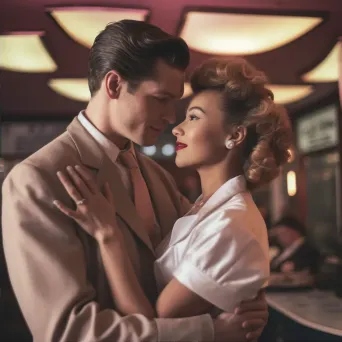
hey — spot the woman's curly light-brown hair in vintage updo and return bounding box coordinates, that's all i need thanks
[191,58,292,188]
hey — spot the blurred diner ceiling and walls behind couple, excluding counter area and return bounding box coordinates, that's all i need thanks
[0,0,342,341]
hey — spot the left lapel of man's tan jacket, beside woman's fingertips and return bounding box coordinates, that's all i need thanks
[67,118,154,253]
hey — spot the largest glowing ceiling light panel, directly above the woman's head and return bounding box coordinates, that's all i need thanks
[181,12,322,55]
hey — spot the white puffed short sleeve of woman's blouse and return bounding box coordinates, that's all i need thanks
[173,210,269,312]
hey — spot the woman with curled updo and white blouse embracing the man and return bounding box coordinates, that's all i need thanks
[56,59,291,317]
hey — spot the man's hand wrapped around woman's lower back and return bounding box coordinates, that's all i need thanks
[214,291,268,342]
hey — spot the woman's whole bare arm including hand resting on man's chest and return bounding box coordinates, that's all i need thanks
[54,167,264,324]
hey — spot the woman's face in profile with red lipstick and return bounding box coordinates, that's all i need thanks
[172,90,228,169]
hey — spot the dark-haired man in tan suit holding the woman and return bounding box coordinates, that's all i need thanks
[3,20,267,342]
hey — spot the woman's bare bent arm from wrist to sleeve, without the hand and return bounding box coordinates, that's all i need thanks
[97,228,212,318]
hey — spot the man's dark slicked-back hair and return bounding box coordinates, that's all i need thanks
[88,20,190,96]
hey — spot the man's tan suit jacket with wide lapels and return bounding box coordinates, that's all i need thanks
[2,119,213,342]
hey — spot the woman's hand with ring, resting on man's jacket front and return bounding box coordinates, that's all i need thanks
[53,165,121,242]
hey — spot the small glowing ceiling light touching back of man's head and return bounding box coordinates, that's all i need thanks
[48,78,90,102]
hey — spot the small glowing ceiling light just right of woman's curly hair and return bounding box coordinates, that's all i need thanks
[267,84,313,104]
